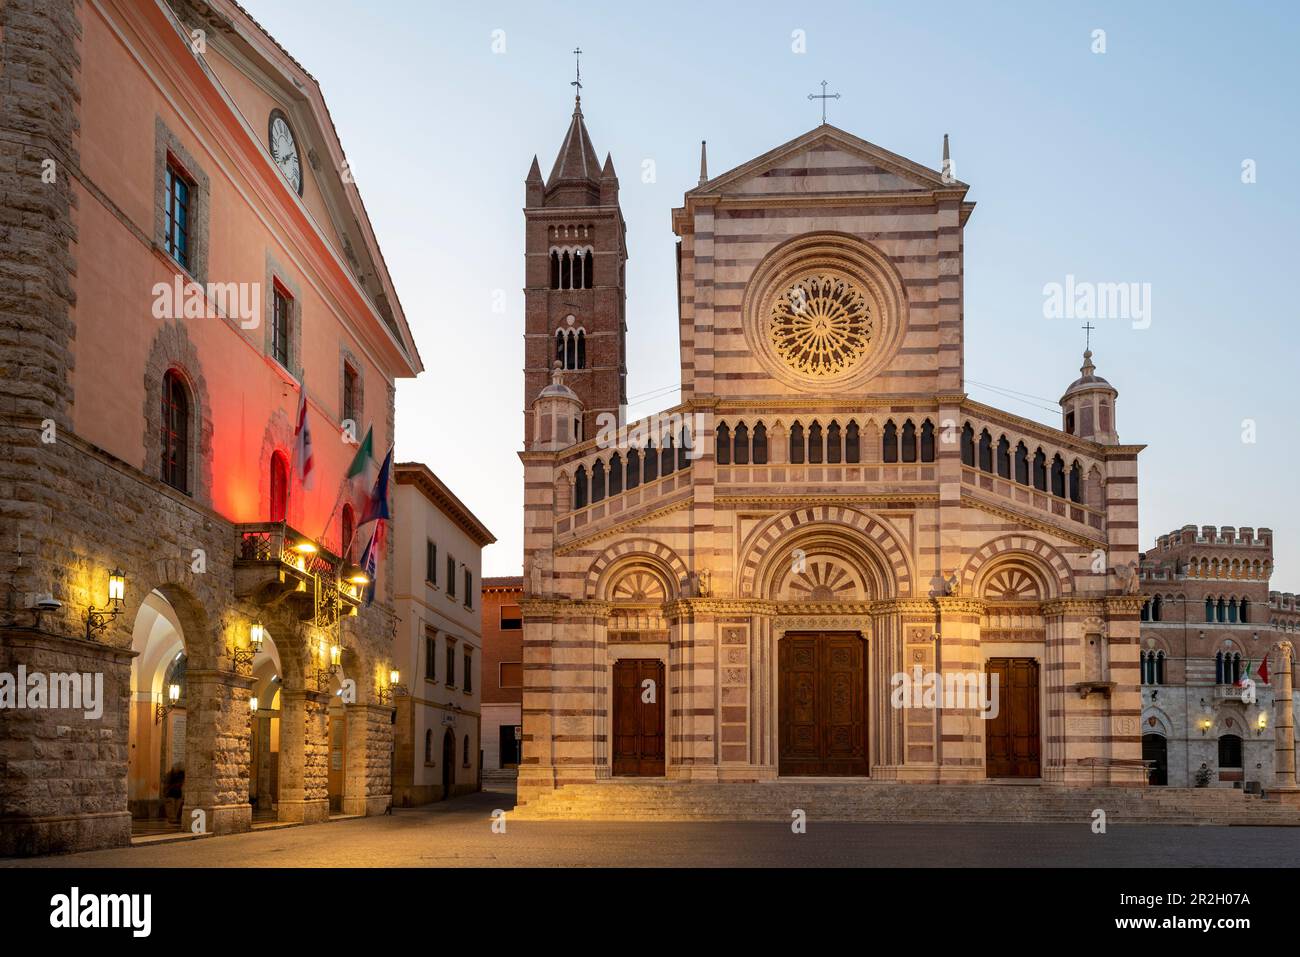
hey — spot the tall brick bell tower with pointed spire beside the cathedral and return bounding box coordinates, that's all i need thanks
[524,71,628,442]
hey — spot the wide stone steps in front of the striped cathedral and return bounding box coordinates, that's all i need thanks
[511,781,1300,826]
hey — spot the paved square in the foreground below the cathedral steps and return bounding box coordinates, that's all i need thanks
[0,791,1300,867]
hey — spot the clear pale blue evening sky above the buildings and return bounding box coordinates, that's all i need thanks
[244,0,1300,590]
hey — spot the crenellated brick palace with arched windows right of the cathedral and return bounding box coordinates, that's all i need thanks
[1140,525,1300,791]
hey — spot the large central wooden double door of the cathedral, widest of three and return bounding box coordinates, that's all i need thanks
[777,632,870,776]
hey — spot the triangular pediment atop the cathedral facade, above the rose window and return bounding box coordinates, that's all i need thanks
[686,124,969,198]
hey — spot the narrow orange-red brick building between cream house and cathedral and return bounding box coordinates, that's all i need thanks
[482,575,524,771]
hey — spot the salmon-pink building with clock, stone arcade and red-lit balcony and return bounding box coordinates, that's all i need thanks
[0,0,421,856]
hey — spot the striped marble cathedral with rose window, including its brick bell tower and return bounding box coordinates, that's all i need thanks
[519,101,1147,804]
